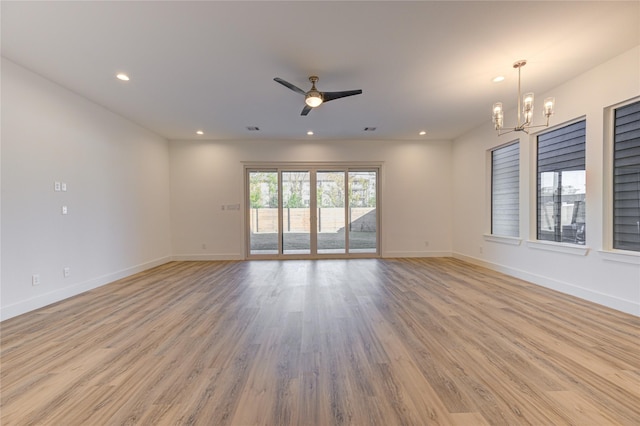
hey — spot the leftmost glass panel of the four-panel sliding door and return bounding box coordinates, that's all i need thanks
[249,171,279,254]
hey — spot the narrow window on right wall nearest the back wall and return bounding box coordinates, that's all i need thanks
[491,141,520,237]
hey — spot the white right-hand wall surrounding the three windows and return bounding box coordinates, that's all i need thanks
[453,47,640,315]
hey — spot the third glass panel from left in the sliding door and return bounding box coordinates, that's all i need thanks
[316,171,346,254]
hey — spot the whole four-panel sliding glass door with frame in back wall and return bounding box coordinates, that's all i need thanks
[246,166,379,258]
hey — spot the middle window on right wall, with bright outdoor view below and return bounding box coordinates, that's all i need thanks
[537,120,586,244]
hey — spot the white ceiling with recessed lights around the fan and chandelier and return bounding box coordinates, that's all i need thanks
[0,0,640,139]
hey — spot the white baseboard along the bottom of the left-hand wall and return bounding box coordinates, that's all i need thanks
[0,256,172,321]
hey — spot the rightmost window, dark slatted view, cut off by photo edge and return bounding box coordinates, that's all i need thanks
[613,102,640,251]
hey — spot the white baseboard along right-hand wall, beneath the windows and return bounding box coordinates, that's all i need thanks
[453,253,640,316]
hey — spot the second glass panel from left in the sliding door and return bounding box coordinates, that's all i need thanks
[281,171,311,254]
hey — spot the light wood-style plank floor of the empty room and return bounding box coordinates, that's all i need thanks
[0,258,640,426]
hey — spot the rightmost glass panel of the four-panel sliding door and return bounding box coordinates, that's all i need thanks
[348,171,378,253]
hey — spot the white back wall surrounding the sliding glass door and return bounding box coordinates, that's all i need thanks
[169,138,451,259]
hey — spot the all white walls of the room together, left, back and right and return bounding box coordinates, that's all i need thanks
[6,47,640,319]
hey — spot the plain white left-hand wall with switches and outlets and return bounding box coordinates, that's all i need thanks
[0,59,171,319]
